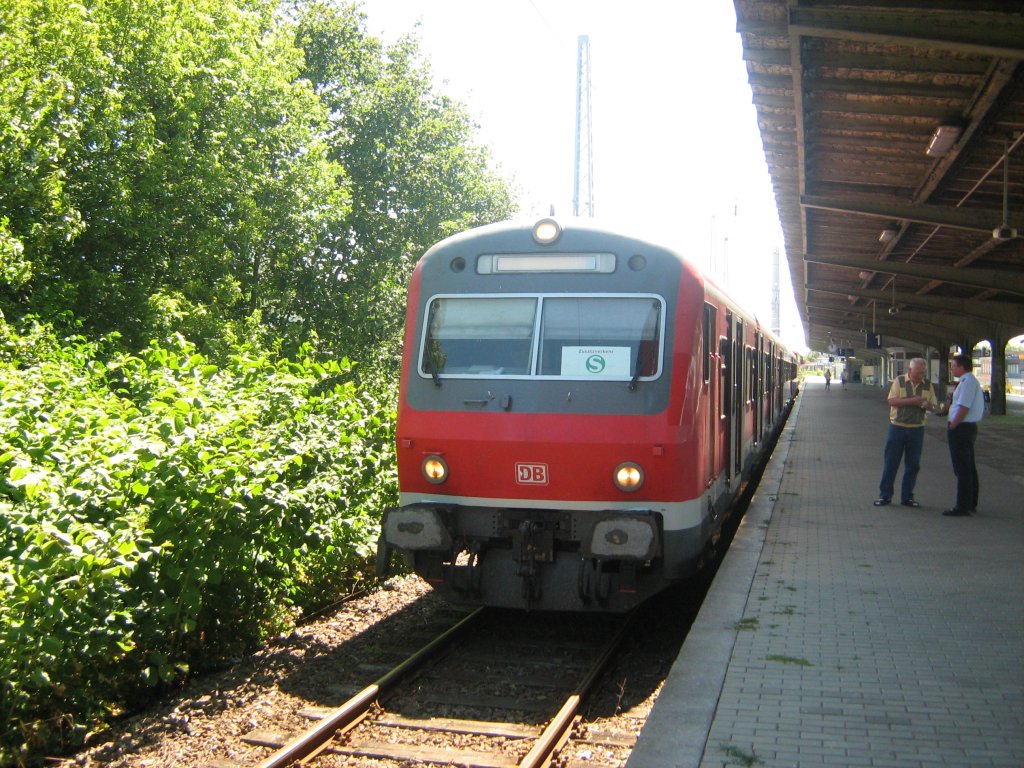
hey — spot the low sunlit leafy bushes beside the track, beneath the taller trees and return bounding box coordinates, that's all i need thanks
[0,323,395,762]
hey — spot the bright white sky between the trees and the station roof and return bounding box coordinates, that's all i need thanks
[360,0,805,349]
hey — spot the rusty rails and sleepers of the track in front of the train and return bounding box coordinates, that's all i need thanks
[212,608,635,768]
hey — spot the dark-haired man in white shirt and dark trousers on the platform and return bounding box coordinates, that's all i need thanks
[942,354,985,517]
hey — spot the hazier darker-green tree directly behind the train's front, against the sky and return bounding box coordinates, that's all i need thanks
[260,0,514,359]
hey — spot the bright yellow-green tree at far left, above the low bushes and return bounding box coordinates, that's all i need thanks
[0,0,347,345]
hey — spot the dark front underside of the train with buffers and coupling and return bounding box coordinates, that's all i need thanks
[378,504,700,612]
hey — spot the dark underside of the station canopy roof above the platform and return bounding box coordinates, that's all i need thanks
[735,0,1024,351]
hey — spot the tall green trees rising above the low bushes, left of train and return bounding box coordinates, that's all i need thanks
[0,0,512,360]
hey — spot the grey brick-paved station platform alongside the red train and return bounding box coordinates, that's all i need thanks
[628,381,1024,768]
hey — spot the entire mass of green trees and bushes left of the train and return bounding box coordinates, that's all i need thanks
[0,0,513,762]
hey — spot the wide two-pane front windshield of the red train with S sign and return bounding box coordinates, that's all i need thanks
[420,294,665,382]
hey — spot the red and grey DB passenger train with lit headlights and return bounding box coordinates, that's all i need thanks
[377,216,799,612]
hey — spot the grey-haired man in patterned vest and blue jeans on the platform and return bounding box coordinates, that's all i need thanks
[874,357,938,507]
